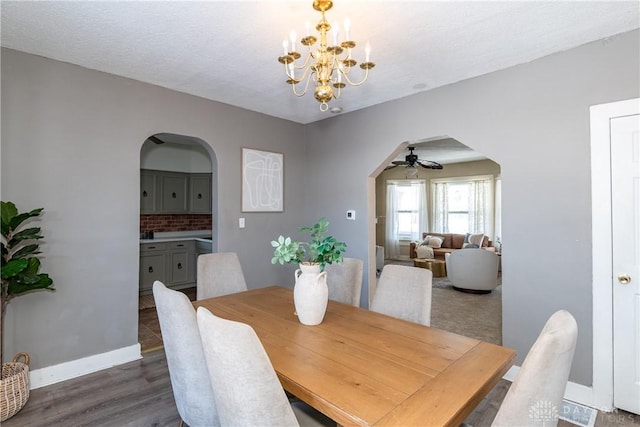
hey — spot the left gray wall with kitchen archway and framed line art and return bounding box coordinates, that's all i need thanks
[2,49,305,369]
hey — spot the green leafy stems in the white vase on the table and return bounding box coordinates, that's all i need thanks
[271,218,347,270]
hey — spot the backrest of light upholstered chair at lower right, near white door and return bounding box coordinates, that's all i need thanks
[492,310,578,426]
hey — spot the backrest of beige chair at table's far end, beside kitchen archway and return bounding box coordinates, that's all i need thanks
[196,252,247,300]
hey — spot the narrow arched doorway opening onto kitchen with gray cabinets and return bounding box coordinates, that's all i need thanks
[138,133,218,352]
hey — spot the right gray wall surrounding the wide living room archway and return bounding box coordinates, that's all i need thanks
[305,31,640,385]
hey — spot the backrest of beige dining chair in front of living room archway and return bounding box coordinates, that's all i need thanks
[371,264,433,326]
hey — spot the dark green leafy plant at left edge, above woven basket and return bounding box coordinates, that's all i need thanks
[0,202,55,368]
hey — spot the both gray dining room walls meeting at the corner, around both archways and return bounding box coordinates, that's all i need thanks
[1,27,640,385]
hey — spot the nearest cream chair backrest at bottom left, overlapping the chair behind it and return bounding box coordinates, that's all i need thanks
[197,307,298,427]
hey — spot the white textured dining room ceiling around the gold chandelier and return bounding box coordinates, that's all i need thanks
[1,0,640,123]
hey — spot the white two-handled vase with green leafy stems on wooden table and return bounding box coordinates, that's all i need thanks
[271,218,347,325]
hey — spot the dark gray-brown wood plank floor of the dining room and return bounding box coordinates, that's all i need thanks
[2,286,640,427]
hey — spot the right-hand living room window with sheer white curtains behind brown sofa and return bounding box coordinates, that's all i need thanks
[431,175,494,236]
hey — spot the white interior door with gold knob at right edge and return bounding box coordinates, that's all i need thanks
[610,115,640,414]
